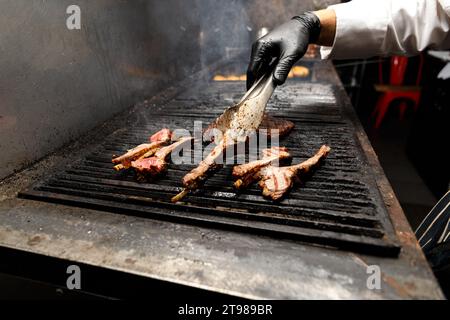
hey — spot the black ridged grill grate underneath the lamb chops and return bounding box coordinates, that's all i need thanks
[19,63,400,256]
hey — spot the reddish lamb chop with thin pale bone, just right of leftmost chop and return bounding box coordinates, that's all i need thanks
[131,137,193,181]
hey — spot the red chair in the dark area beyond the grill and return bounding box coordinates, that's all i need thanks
[372,55,423,129]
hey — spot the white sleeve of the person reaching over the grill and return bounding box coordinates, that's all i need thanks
[320,0,450,59]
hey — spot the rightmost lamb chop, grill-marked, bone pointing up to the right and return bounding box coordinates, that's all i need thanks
[259,145,331,201]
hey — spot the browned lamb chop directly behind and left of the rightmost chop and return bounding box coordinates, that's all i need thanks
[233,147,292,189]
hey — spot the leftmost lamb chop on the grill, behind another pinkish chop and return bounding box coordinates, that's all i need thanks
[112,128,172,171]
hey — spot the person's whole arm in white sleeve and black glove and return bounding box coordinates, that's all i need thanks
[247,0,450,88]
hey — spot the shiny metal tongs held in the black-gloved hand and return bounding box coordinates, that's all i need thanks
[214,64,276,139]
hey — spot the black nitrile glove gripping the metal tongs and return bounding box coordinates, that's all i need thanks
[247,12,320,89]
